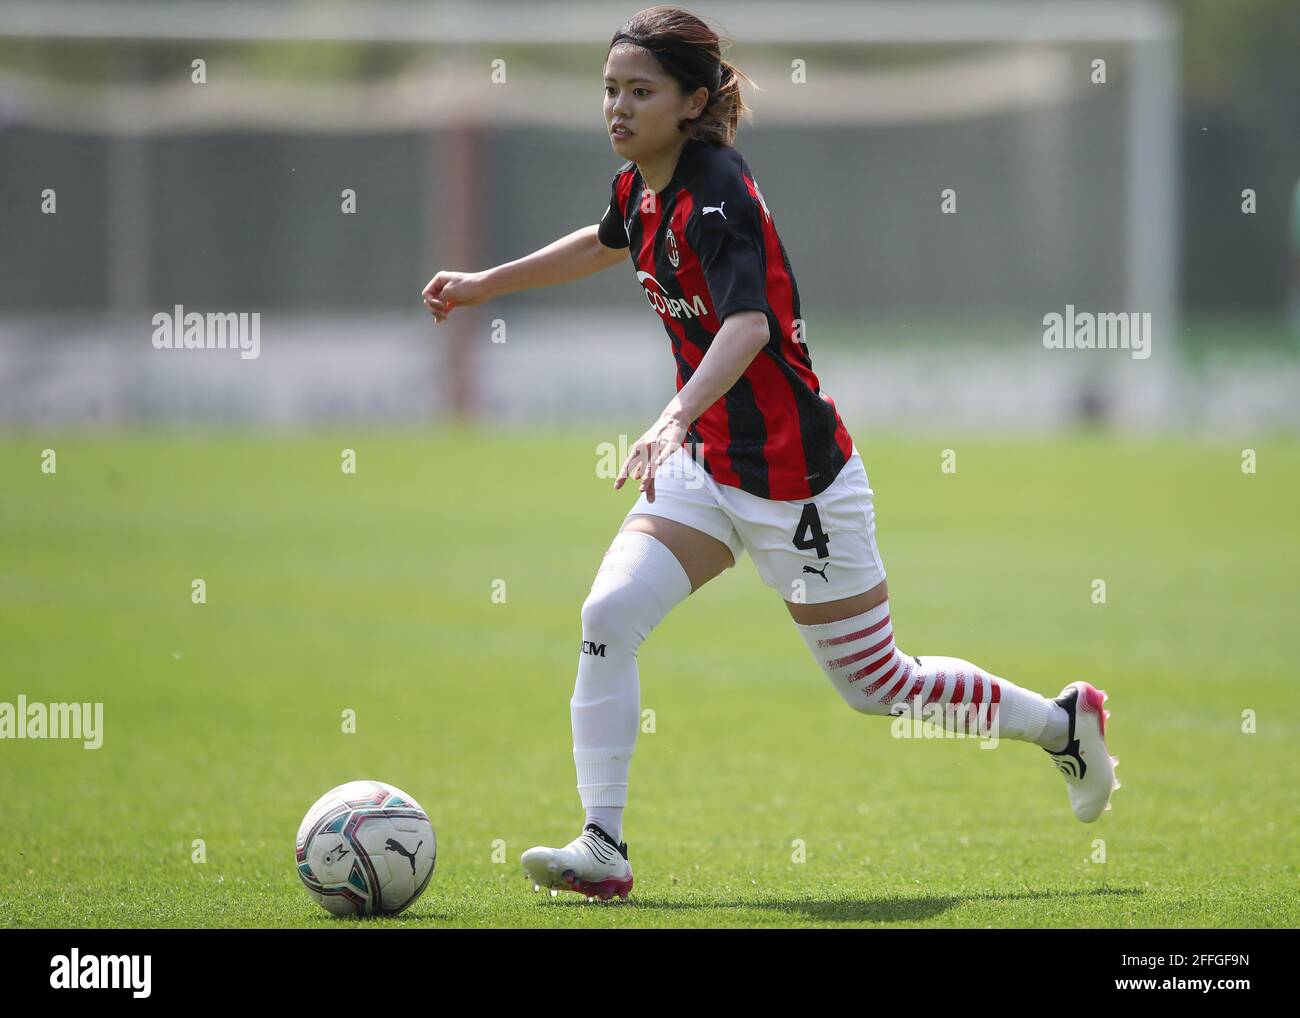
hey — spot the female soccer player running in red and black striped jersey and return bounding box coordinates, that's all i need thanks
[424,7,1119,900]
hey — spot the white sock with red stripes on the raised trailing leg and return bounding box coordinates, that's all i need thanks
[798,601,1070,750]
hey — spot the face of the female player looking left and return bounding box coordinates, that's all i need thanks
[605,43,709,161]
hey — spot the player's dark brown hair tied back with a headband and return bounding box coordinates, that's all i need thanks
[606,5,758,146]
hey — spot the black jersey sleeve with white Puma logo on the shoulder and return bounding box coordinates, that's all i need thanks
[686,171,770,324]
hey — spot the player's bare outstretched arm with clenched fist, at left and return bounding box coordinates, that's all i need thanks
[424,225,628,321]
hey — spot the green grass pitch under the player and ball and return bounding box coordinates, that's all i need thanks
[0,429,1300,927]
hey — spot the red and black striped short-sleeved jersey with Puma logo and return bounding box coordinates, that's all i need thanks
[599,139,853,501]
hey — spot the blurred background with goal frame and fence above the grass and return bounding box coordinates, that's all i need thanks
[0,0,1300,433]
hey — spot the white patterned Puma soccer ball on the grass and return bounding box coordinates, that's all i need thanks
[295,781,438,915]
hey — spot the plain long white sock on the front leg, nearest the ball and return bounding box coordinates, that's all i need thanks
[569,530,690,841]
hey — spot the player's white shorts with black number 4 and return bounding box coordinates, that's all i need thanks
[624,446,885,605]
